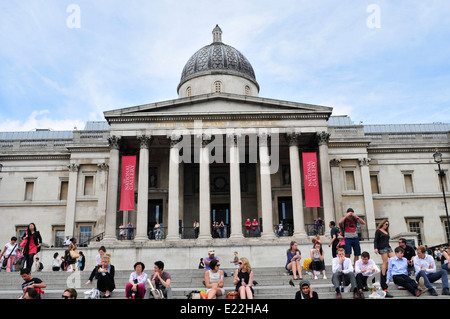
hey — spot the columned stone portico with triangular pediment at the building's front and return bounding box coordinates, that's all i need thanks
[101,93,334,244]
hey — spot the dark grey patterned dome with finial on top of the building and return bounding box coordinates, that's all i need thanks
[178,25,259,90]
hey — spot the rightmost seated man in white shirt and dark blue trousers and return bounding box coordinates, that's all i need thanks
[414,246,450,296]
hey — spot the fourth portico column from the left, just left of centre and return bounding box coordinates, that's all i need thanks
[198,134,211,240]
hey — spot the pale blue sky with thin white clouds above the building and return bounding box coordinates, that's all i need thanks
[0,0,450,131]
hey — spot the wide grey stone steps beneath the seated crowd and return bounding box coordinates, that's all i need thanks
[0,266,450,299]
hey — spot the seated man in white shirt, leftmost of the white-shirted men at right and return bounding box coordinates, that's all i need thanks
[331,248,360,299]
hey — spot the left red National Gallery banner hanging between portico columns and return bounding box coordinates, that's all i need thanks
[120,156,136,211]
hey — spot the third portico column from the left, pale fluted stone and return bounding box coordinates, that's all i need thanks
[166,136,181,240]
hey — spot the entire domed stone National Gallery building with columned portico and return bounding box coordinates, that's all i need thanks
[0,26,450,269]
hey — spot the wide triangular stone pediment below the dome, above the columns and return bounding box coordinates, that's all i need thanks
[104,93,332,121]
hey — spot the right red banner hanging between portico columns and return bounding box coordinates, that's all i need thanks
[303,153,320,207]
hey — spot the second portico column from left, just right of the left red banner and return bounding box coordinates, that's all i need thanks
[134,135,152,242]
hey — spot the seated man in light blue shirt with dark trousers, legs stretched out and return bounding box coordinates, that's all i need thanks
[386,247,428,297]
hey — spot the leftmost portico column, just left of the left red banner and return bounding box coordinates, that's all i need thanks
[103,135,121,243]
